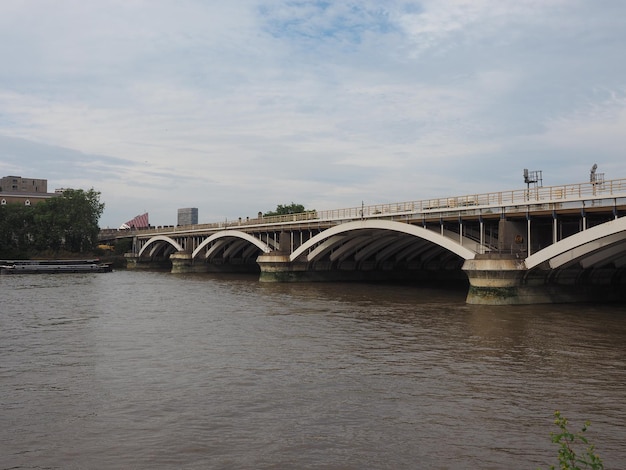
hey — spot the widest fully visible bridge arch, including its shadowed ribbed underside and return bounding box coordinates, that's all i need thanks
[289,219,476,266]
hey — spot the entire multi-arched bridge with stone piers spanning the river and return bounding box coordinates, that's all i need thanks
[100,179,626,304]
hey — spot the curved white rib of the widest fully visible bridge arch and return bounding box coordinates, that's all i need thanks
[289,219,476,261]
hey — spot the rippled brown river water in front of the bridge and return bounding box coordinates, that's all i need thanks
[0,271,626,470]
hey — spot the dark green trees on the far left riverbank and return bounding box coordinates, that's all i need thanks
[0,189,104,259]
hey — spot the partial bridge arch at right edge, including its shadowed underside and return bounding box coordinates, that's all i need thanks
[525,217,626,270]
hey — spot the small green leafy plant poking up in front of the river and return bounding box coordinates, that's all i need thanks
[550,411,604,470]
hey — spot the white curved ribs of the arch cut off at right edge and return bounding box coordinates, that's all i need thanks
[525,217,626,269]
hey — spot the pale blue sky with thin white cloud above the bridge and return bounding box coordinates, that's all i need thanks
[0,0,626,228]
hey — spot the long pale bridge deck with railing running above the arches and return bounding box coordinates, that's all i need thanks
[100,179,626,240]
